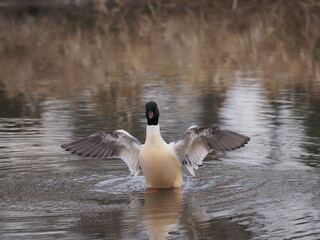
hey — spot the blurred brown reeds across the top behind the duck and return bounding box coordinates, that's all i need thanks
[0,0,320,114]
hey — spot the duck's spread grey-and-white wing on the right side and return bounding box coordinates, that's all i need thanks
[171,125,250,176]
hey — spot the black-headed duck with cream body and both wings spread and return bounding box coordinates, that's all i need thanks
[61,101,250,189]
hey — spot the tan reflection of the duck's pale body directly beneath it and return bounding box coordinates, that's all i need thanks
[142,189,183,239]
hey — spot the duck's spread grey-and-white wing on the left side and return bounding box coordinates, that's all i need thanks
[61,130,141,176]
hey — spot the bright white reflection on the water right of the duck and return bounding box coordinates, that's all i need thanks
[221,78,311,169]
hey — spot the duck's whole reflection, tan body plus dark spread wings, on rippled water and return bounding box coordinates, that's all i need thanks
[77,185,250,240]
